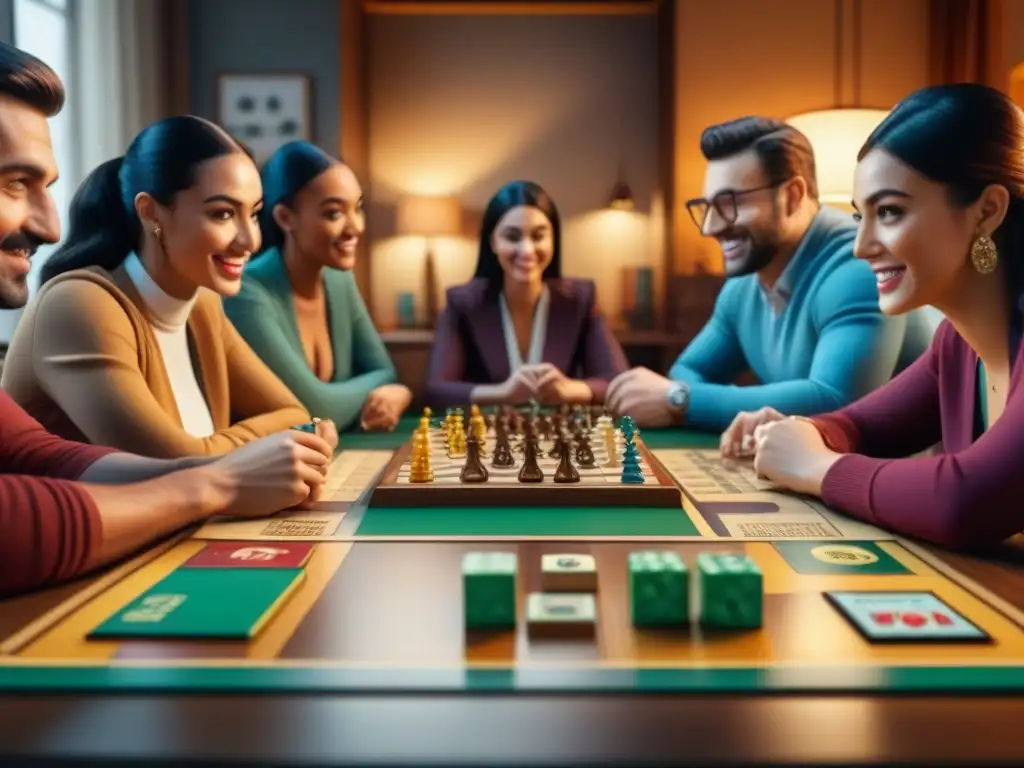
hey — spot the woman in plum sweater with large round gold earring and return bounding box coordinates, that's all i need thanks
[722,84,1024,549]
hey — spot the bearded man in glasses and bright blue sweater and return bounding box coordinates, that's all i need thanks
[605,117,931,431]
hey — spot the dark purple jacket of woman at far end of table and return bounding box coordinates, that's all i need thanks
[424,278,629,408]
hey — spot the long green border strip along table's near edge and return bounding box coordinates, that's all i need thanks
[0,665,1024,695]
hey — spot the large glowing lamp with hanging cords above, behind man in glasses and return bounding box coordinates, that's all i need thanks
[785,0,889,206]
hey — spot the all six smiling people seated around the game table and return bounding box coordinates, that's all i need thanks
[0,37,1024,595]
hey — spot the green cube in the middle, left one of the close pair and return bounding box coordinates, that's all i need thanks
[629,550,690,627]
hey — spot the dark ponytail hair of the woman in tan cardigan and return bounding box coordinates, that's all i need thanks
[40,115,245,283]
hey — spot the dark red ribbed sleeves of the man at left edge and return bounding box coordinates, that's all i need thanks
[0,392,114,597]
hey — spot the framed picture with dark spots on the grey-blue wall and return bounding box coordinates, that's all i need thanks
[217,75,312,163]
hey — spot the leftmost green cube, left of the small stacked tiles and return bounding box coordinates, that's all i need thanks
[462,552,518,630]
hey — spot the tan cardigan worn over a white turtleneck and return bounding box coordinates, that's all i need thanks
[0,266,309,459]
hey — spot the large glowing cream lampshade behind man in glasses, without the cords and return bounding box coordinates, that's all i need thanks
[785,109,889,205]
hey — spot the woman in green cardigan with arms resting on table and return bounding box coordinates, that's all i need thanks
[224,141,412,430]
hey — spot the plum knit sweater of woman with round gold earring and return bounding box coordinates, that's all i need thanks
[815,331,1024,550]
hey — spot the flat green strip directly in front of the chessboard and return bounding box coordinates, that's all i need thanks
[355,507,700,537]
